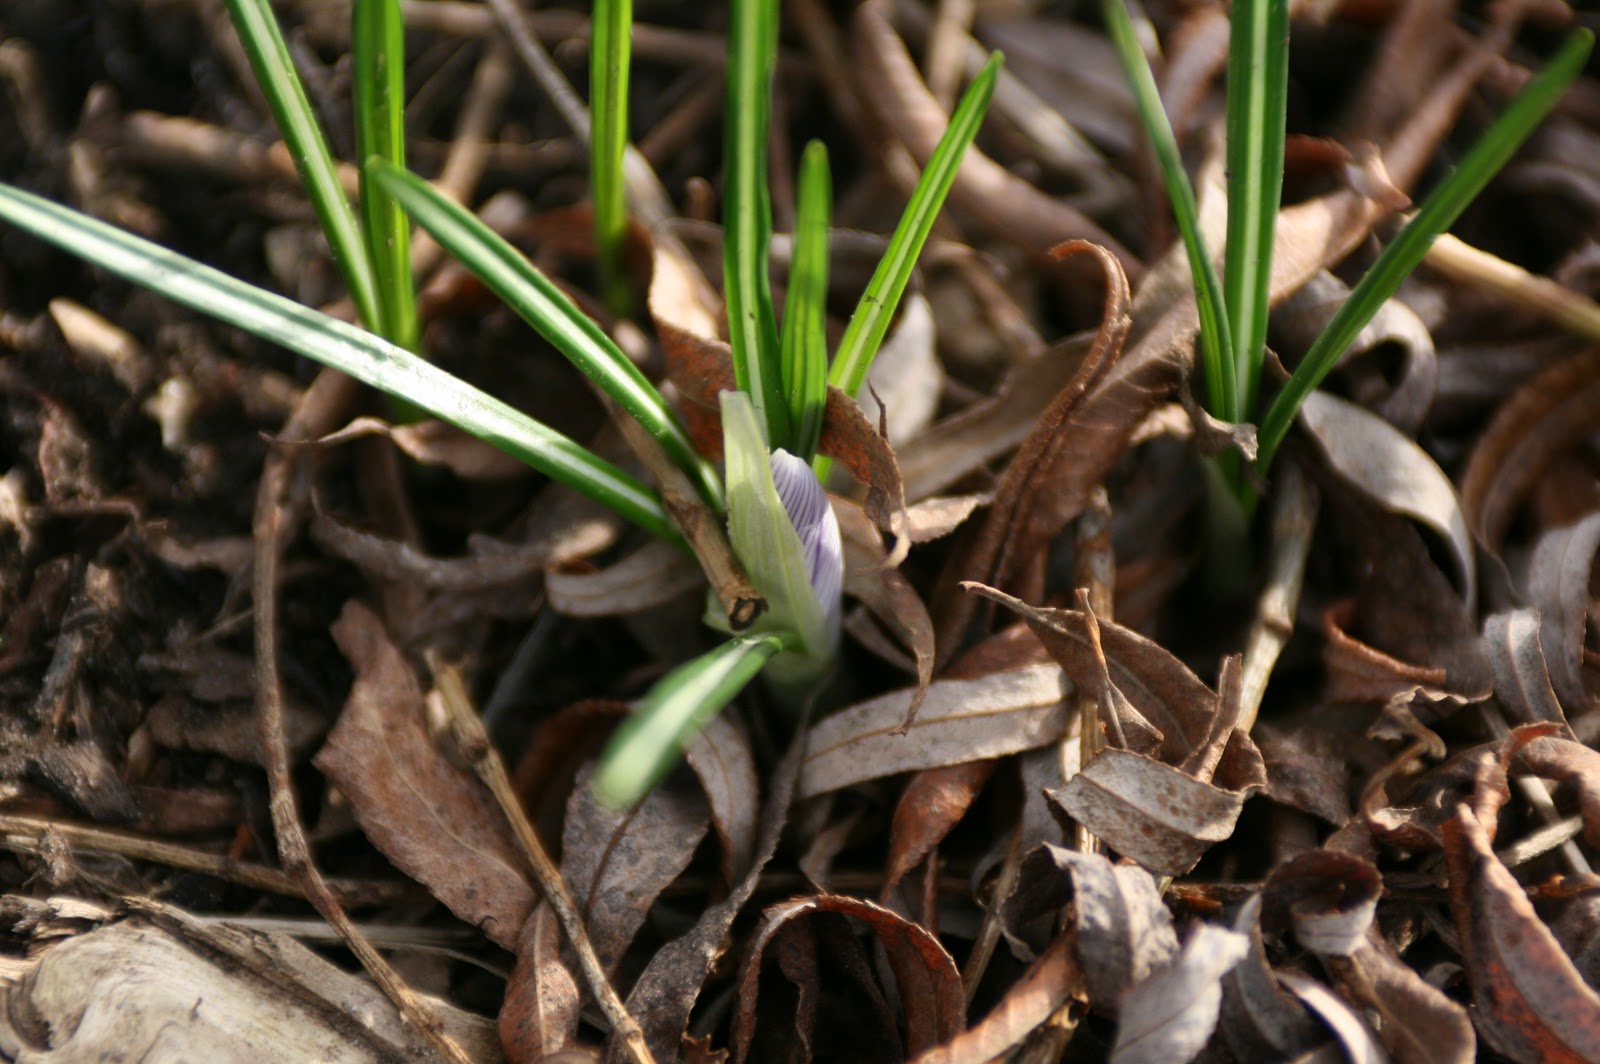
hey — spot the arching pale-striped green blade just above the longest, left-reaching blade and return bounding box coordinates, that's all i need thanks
[371,160,722,510]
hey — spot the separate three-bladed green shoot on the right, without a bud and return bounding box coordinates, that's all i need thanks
[1101,0,1594,506]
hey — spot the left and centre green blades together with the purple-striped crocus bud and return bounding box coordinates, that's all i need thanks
[0,0,998,805]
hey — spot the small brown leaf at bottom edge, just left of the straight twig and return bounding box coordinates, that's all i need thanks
[499,902,581,1064]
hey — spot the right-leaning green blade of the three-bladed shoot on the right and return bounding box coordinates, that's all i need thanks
[1256,30,1594,472]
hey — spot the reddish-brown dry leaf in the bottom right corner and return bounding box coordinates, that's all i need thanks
[1443,805,1600,1064]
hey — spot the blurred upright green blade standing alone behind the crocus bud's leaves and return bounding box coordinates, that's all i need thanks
[589,0,634,314]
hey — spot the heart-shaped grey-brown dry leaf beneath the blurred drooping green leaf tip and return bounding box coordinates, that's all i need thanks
[562,764,710,971]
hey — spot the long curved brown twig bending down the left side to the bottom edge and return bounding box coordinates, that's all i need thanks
[253,370,470,1064]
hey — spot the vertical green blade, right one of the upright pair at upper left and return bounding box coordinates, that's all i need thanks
[350,0,418,350]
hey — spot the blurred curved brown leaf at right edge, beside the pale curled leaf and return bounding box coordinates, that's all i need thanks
[1461,350,1600,555]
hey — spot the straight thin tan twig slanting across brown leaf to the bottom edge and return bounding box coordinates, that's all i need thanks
[427,653,654,1064]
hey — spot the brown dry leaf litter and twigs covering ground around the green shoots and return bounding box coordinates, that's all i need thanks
[0,0,1600,1061]
